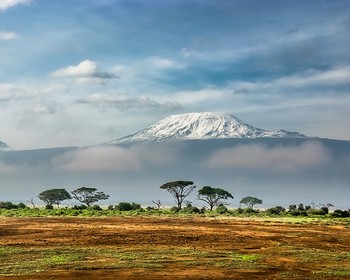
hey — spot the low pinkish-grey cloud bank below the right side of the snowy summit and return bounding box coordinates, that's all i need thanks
[204,142,332,172]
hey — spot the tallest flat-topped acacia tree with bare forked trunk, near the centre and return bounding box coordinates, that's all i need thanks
[160,181,196,210]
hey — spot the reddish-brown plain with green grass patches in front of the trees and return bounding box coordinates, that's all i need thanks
[0,215,350,280]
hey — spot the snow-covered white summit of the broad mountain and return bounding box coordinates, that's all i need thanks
[109,112,306,144]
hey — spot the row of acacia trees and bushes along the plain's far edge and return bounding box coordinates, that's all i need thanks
[0,180,350,217]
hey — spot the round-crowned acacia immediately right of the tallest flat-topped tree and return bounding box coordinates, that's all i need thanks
[197,186,233,211]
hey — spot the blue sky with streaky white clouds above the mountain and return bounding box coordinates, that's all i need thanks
[0,0,350,148]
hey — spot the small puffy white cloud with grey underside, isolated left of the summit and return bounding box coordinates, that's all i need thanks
[52,60,117,83]
